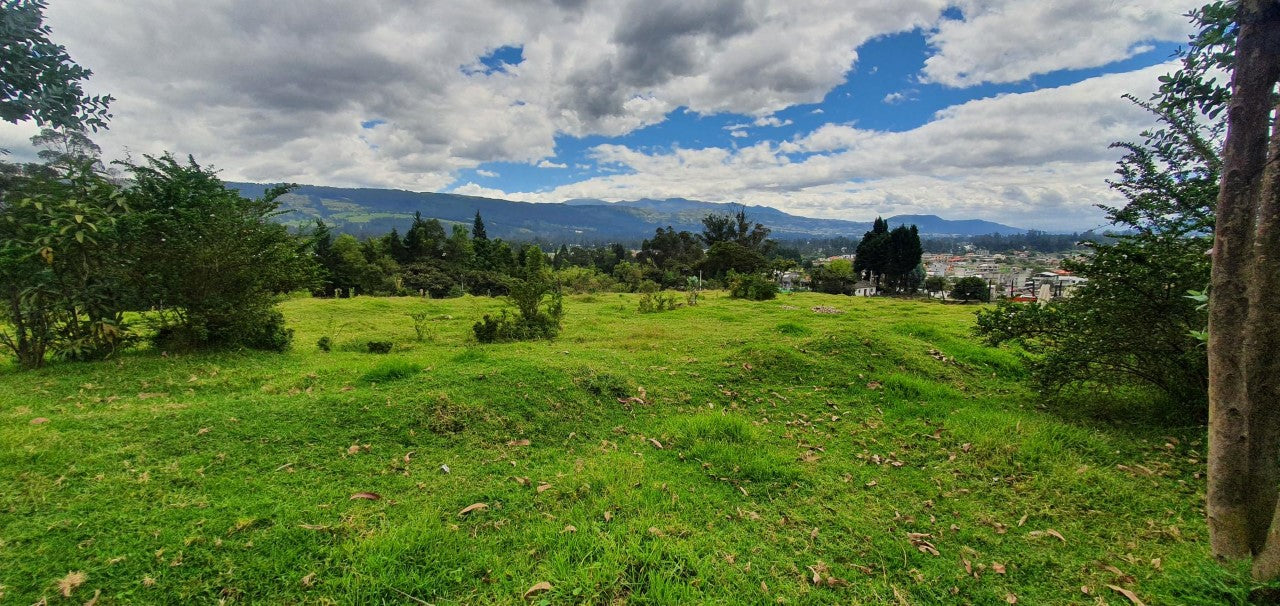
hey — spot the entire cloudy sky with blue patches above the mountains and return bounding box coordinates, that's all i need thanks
[0,0,1198,231]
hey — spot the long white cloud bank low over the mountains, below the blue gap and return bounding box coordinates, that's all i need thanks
[468,64,1174,228]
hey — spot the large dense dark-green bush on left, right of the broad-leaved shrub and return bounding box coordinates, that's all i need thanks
[118,155,314,351]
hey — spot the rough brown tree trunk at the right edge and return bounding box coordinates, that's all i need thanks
[1207,0,1280,579]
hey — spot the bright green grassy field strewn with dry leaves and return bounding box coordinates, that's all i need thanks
[0,293,1248,605]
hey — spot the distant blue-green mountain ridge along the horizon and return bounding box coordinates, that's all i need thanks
[227,182,1027,243]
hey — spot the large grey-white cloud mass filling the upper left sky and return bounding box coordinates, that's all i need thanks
[47,0,947,188]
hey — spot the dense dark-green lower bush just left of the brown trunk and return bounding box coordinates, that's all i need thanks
[977,238,1208,409]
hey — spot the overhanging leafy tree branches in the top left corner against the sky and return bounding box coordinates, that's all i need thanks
[0,0,114,131]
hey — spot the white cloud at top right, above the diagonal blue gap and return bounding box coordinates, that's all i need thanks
[923,0,1203,86]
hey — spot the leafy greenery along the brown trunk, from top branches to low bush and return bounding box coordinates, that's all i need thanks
[978,3,1234,414]
